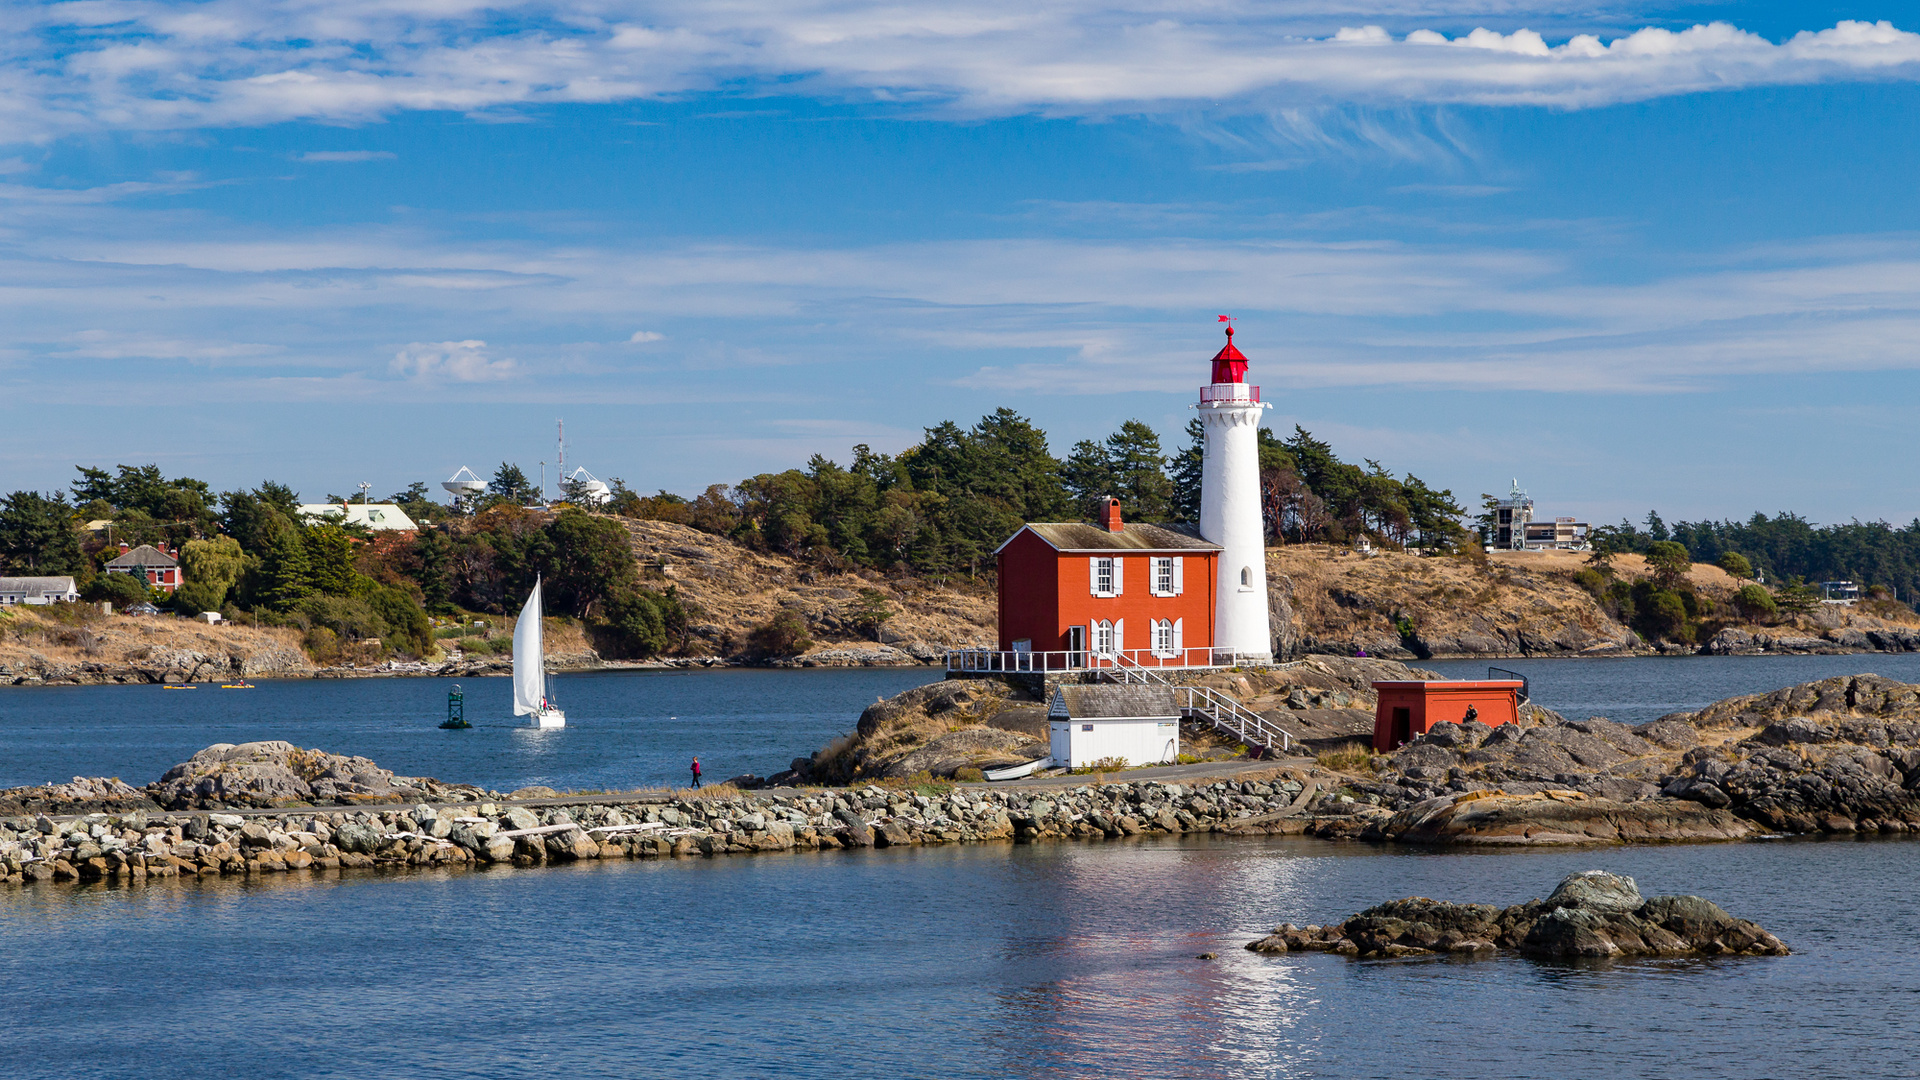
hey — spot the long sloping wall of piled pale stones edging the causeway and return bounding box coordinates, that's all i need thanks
[0,776,1336,884]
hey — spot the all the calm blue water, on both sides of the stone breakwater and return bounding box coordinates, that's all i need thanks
[11,655,1920,1080]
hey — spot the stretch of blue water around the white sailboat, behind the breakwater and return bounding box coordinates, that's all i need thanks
[0,667,941,792]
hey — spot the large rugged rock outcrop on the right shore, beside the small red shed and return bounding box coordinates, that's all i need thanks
[1327,675,1920,844]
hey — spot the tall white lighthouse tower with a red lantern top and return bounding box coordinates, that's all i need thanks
[1196,323,1273,663]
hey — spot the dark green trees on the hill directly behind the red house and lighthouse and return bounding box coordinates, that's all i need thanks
[599,407,1469,575]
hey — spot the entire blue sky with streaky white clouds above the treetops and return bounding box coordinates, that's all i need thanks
[0,0,1920,523]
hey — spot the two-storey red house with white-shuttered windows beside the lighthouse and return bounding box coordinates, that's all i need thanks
[995,500,1219,671]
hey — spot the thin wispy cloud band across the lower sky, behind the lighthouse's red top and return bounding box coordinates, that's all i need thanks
[0,206,1920,402]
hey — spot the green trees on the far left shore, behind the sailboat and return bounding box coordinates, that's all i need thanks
[0,465,685,661]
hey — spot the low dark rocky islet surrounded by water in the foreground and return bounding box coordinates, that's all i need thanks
[1246,871,1788,959]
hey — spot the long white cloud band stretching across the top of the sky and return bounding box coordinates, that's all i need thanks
[0,0,1920,139]
